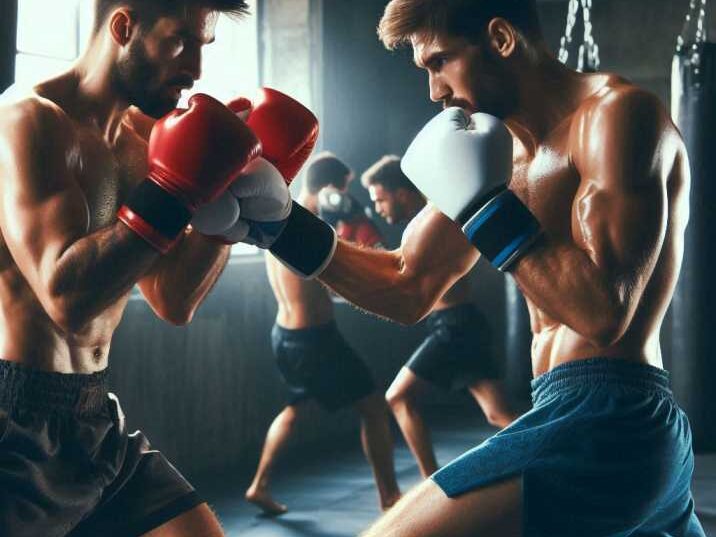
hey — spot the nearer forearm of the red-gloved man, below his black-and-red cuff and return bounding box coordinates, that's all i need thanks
[50,222,159,331]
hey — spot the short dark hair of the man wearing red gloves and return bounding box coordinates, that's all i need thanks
[93,0,249,34]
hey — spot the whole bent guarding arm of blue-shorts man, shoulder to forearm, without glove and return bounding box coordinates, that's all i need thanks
[514,89,678,347]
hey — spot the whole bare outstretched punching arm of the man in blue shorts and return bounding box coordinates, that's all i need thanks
[319,205,479,324]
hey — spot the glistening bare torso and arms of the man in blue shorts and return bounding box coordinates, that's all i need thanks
[320,74,689,376]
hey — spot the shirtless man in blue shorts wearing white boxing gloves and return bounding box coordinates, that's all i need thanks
[210,0,704,537]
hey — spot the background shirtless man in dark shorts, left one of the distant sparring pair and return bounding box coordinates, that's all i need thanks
[246,153,400,515]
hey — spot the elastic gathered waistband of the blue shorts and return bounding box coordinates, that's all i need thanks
[531,357,671,404]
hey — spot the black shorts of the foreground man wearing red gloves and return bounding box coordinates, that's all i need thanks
[0,360,202,537]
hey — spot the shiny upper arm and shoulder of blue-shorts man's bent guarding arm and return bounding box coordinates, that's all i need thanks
[572,91,669,284]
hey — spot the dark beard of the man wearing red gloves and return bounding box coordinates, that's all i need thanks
[111,41,177,119]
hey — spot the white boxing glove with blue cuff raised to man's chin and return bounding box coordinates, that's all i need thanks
[401,107,540,271]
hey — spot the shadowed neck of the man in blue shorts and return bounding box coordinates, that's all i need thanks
[505,49,597,150]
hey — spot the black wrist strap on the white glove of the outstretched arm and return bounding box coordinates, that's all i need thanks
[269,201,337,279]
